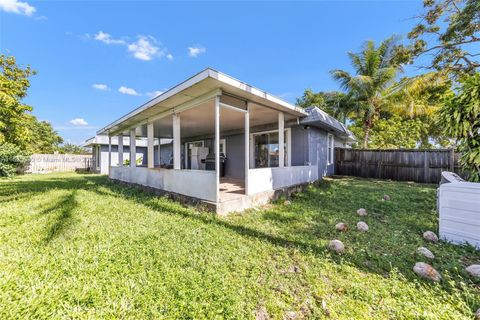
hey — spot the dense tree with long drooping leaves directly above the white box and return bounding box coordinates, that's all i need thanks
[440,73,480,182]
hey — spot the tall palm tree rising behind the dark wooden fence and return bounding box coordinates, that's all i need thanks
[331,37,401,148]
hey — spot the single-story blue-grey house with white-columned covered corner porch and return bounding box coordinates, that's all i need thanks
[97,68,352,213]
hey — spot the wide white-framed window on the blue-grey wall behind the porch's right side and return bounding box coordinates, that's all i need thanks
[250,129,291,168]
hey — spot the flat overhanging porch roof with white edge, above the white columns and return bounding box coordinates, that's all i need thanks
[97,68,308,134]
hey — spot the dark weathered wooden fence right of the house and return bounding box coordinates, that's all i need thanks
[335,148,458,183]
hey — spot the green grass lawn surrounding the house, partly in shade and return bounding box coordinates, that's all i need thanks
[0,174,480,319]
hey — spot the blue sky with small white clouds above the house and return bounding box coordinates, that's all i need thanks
[0,0,422,144]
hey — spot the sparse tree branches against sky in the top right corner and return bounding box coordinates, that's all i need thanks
[399,0,480,76]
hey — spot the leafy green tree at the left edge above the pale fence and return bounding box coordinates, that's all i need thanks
[0,55,63,153]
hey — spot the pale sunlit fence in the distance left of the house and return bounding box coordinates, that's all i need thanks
[25,154,92,173]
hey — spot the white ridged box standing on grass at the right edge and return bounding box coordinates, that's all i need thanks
[437,172,480,249]
